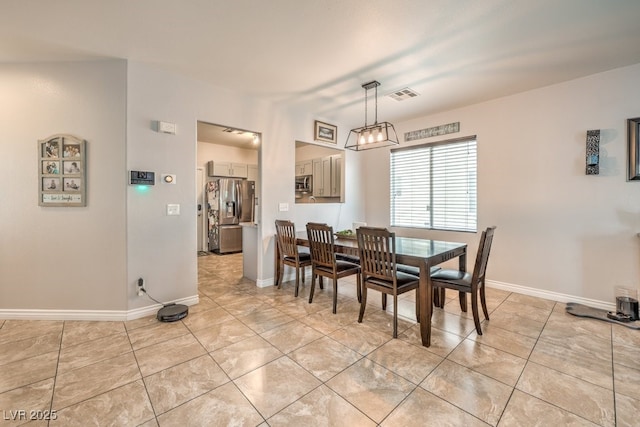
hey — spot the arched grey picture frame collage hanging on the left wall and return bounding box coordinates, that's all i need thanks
[38,134,87,207]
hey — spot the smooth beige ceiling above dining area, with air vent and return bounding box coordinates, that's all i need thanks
[0,0,640,132]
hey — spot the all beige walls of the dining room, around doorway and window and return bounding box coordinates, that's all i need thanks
[6,60,640,319]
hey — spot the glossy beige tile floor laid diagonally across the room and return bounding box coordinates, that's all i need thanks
[0,255,640,426]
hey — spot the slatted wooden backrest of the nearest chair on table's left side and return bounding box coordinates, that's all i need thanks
[356,227,396,281]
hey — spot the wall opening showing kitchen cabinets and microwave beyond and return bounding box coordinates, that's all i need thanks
[295,141,344,203]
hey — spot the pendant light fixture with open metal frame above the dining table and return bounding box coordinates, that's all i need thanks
[344,80,399,151]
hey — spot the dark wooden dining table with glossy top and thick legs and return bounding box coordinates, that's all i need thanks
[274,232,467,347]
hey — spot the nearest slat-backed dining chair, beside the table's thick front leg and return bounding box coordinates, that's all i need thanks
[356,227,420,338]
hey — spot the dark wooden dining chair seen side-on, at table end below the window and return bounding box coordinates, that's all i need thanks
[431,226,496,335]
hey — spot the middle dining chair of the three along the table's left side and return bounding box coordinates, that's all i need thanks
[307,222,362,314]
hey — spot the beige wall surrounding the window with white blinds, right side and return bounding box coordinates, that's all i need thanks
[362,64,640,303]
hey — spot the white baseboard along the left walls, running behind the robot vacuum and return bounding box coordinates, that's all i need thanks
[0,295,200,322]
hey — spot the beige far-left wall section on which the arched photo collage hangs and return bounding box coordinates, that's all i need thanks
[0,60,127,315]
